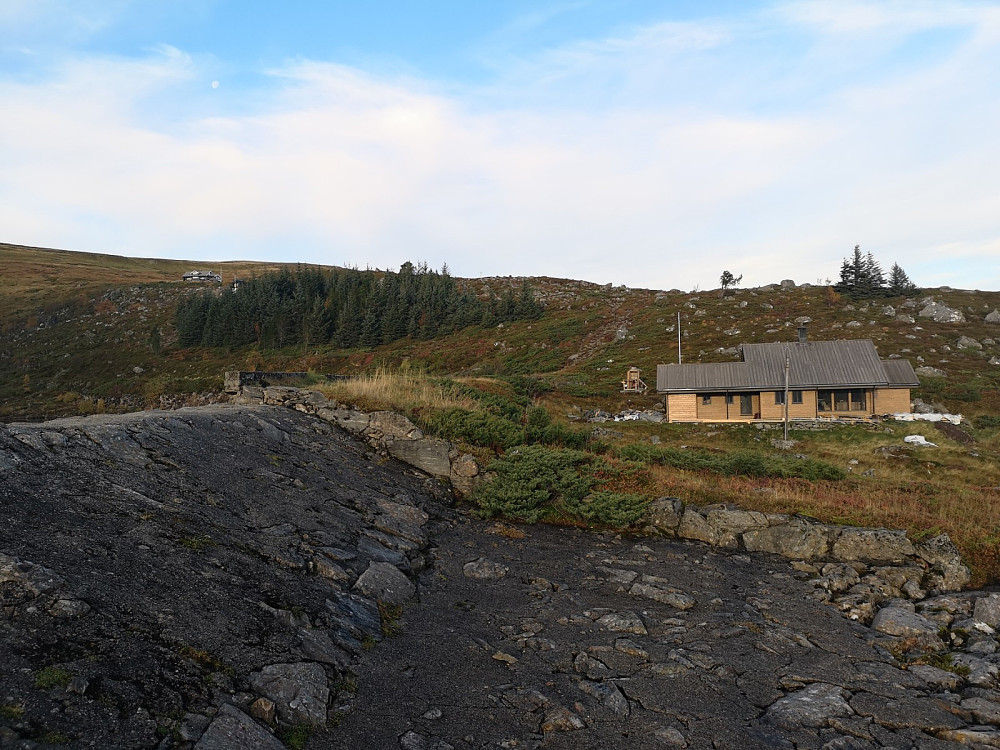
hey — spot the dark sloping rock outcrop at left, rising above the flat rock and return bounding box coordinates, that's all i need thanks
[0,408,438,750]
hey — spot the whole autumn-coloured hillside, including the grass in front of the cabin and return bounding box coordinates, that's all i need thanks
[0,246,1000,583]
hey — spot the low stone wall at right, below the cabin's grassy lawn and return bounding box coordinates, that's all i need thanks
[646,497,971,623]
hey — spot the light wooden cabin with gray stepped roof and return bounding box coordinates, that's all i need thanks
[656,328,920,422]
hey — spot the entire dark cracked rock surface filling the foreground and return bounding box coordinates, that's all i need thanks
[0,406,1000,750]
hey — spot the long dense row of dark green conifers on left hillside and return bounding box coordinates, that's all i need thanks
[175,262,542,348]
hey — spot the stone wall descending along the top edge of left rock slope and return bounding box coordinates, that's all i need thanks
[234,384,480,497]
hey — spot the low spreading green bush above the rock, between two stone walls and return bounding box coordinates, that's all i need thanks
[473,445,594,523]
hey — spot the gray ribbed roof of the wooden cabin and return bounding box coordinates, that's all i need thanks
[656,339,918,392]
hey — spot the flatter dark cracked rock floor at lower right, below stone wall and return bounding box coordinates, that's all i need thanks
[328,514,1000,750]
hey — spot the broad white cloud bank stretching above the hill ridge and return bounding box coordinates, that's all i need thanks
[0,3,1000,288]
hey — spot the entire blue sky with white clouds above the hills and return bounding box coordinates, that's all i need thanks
[0,0,1000,290]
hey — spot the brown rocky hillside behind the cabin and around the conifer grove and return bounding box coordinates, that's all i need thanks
[0,245,1000,419]
